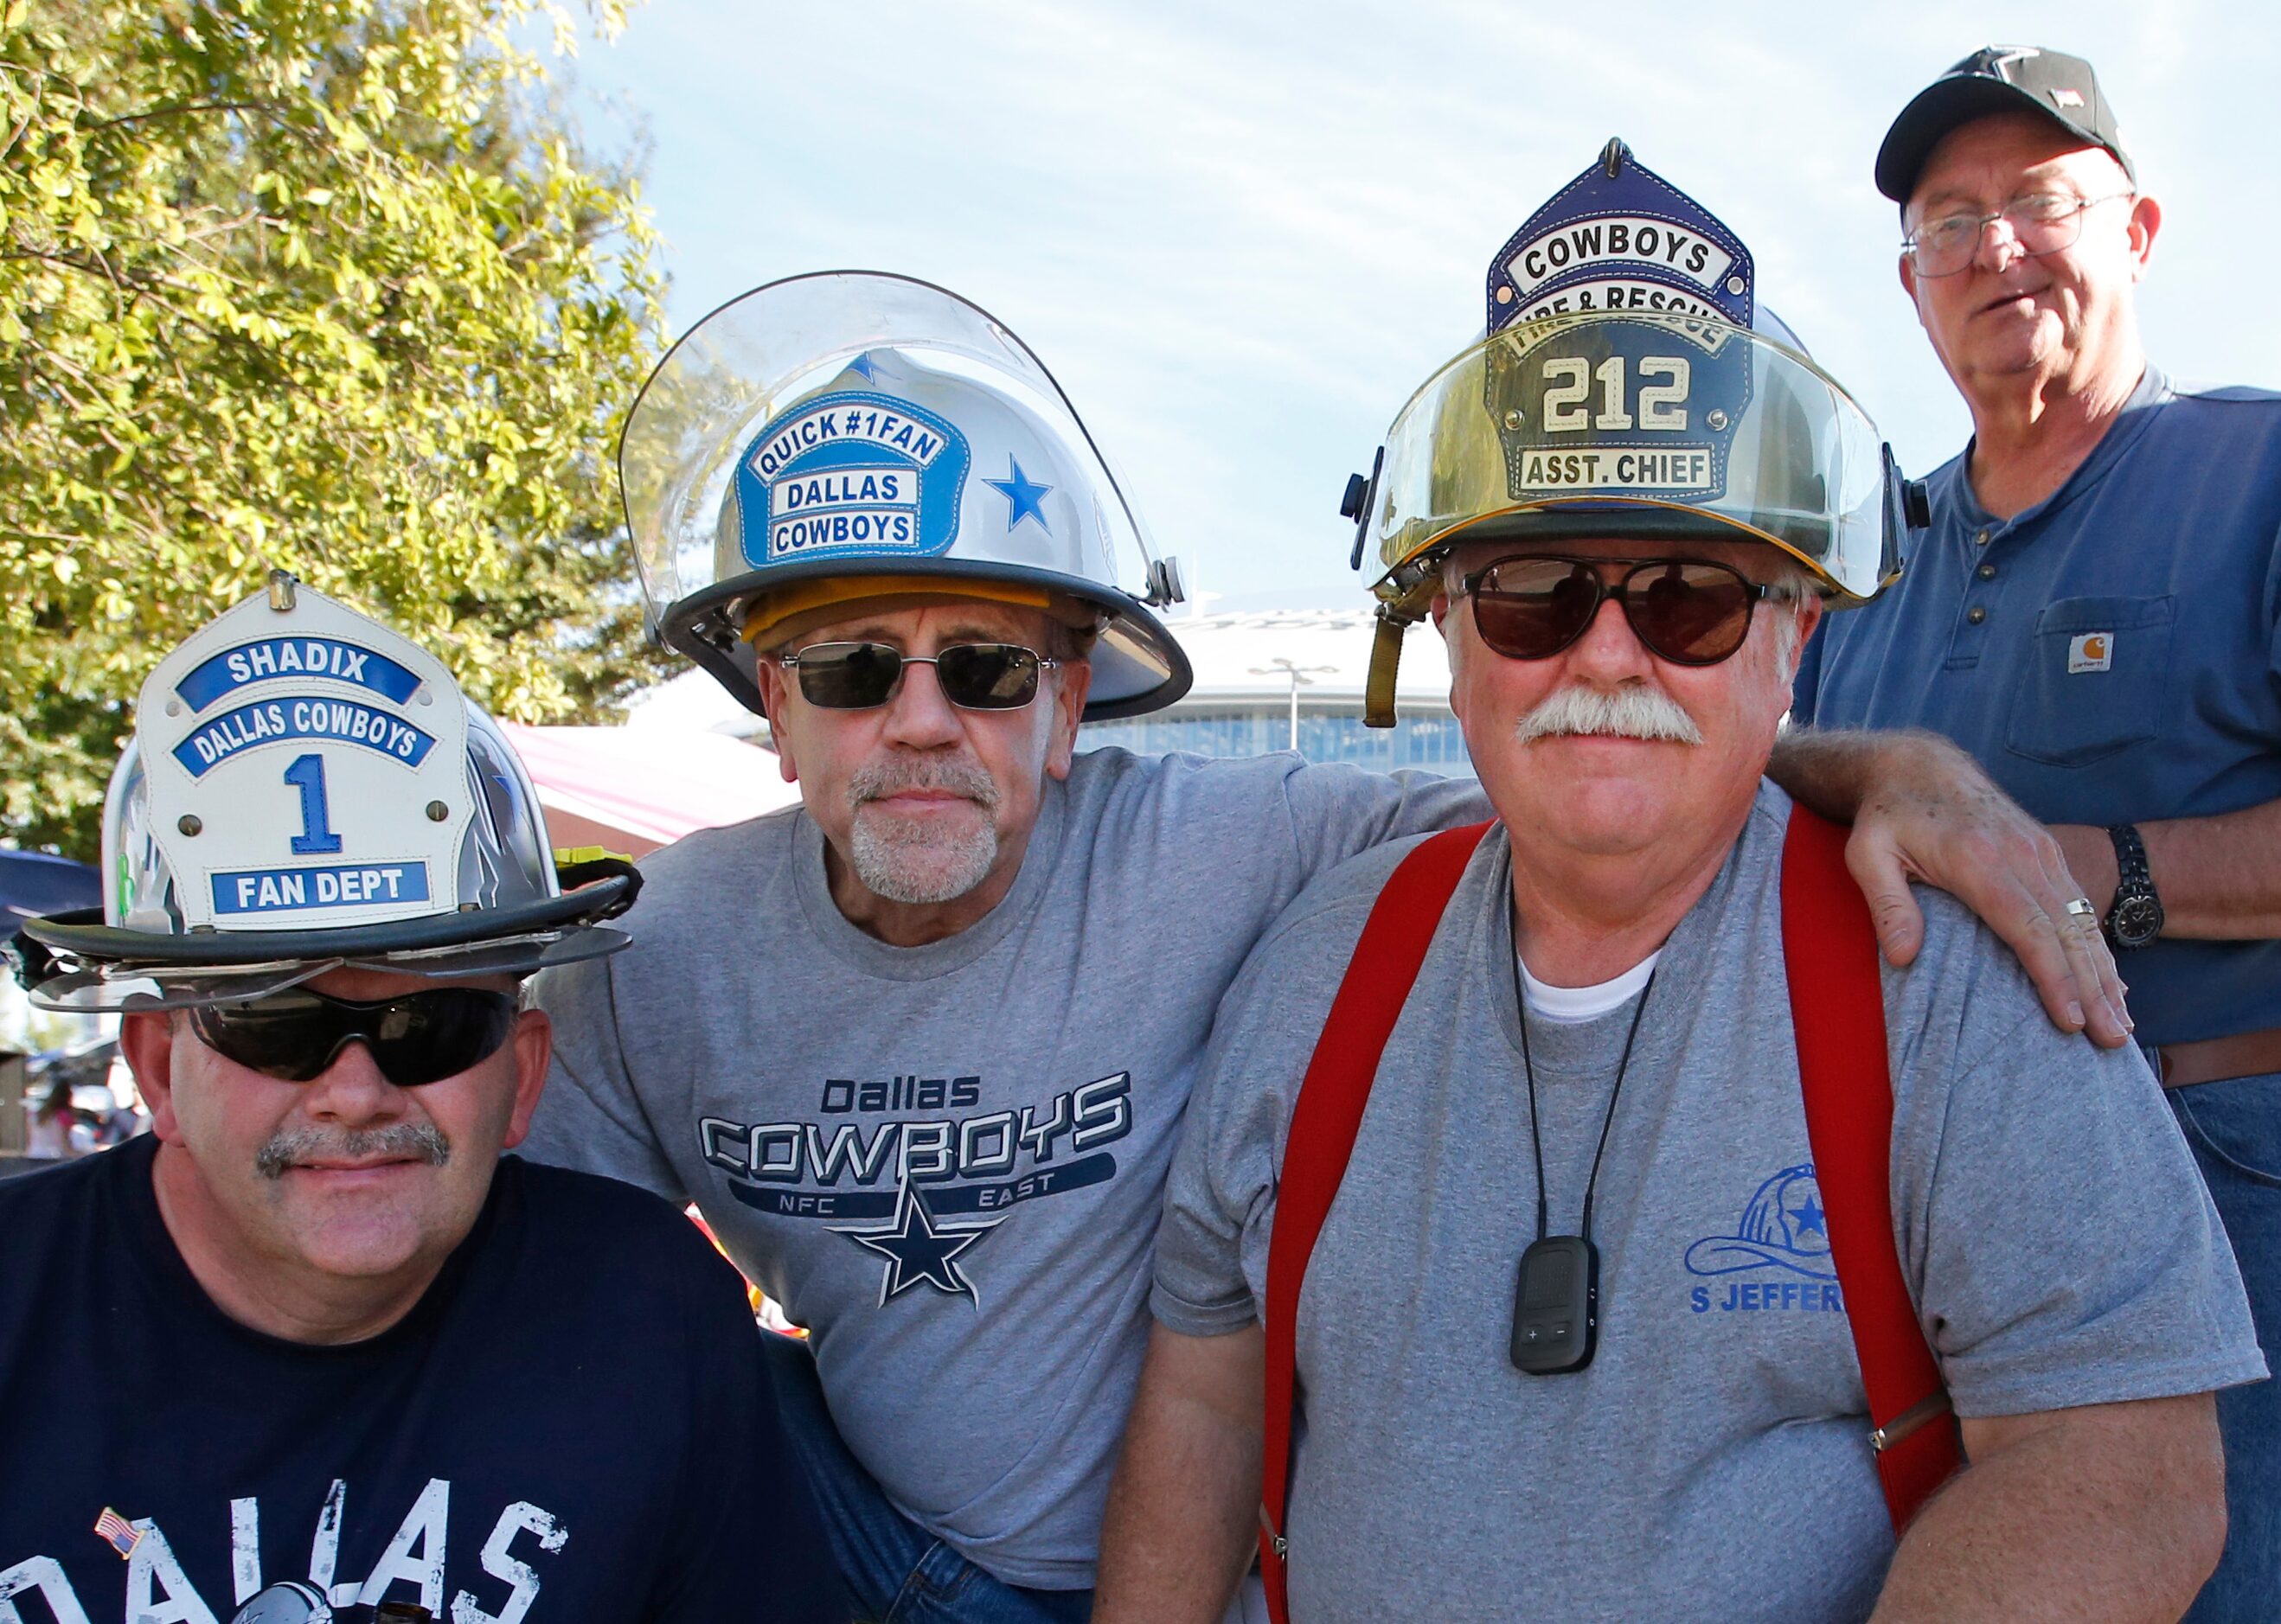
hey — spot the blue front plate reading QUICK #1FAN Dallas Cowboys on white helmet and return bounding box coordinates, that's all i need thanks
[737,390,974,568]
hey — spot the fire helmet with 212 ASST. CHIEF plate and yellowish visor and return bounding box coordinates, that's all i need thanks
[1342,142,1920,727]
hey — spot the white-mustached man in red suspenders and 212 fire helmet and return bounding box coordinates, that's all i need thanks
[1097,142,2263,1624]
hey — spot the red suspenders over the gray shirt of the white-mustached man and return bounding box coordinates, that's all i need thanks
[1259,808,1964,1624]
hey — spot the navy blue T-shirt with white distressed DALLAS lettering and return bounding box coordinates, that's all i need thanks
[0,1138,844,1624]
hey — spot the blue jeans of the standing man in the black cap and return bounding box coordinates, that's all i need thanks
[2169,1072,2281,1624]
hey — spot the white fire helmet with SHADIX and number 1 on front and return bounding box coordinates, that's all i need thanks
[25,572,638,1010]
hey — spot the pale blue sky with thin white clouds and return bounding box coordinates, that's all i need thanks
[547,0,2281,607]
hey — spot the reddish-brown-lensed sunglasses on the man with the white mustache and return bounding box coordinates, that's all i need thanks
[1462,554,1786,666]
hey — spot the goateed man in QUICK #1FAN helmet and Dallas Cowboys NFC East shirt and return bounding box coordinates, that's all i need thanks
[517,263,2121,1620]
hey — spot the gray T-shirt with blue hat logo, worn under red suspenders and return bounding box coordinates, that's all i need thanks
[1154,784,2265,1624]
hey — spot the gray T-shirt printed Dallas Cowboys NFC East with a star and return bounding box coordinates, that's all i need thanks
[522,751,1487,1589]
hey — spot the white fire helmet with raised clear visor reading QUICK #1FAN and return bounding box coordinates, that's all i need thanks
[618,272,1191,720]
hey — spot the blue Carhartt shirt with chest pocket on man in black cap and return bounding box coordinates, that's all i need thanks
[1793,368,2281,1045]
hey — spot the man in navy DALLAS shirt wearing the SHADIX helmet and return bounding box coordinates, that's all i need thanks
[0,572,835,1624]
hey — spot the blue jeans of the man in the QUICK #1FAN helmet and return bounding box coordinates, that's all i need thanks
[764,1337,1092,1624]
